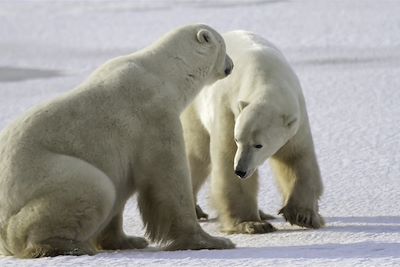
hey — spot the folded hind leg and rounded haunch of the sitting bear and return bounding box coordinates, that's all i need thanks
[6,154,115,258]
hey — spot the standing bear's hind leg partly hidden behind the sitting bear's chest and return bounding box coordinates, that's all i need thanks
[181,105,211,219]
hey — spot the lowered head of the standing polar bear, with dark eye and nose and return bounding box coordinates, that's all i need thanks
[234,101,299,179]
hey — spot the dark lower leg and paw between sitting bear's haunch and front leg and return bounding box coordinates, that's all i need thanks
[97,214,148,250]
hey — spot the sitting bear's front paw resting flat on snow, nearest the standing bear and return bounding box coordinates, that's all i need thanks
[165,232,235,251]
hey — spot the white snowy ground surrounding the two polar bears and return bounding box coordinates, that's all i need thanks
[0,0,400,266]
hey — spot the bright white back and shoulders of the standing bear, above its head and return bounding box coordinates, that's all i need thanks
[193,30,305,135]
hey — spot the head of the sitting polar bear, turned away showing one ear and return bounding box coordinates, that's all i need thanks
[152,24,233,85]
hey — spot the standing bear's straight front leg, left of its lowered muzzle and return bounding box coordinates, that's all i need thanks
[210,108,275,234]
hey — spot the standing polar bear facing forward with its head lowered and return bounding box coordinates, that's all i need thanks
[181,31,324,234]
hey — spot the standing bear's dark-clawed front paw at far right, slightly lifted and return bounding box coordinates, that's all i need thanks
[278,205,325,229]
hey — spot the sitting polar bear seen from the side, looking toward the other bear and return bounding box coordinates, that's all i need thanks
[0,24,234,258]
